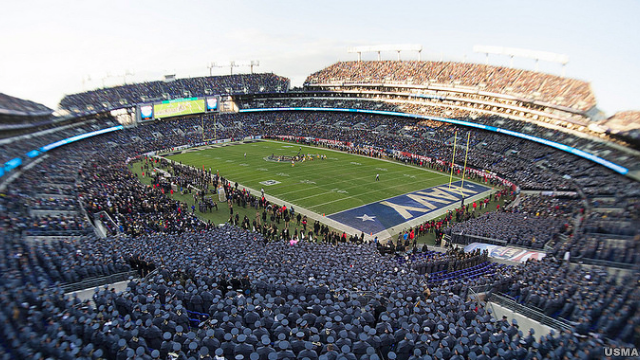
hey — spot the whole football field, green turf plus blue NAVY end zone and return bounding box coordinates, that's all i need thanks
[165,141,489,233]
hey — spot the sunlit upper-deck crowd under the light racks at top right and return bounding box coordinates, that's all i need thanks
[305,61,595,111]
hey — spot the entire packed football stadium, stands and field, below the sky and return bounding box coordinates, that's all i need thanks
[0,44,640,360]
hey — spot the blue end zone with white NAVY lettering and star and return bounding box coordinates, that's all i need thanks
[328,181,490,234]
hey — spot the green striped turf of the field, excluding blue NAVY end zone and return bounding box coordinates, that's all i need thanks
[168,141,458,215]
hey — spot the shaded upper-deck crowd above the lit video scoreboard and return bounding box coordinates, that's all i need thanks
[60,73,289,112]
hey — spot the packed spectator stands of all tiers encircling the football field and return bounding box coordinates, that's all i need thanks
[0,62,640,360]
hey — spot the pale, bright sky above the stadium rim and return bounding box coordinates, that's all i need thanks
[0,0,640,115]
